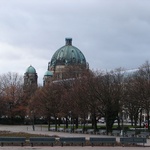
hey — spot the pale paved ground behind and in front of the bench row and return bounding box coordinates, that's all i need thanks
[0,125,150,150]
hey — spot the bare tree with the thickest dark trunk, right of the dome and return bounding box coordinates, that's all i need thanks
[95,69,124,133]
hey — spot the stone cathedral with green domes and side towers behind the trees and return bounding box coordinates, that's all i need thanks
[24,38,89,86]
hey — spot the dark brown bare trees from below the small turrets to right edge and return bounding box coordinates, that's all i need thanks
[28,62,150,133]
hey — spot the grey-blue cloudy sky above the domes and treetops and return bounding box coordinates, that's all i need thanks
[0,0,150,83]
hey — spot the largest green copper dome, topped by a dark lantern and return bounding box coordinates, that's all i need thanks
[49,38,86,68]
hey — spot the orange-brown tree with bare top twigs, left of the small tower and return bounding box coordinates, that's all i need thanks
[0,72,26,123]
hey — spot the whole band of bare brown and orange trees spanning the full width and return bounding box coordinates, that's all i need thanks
[0,62,150,133]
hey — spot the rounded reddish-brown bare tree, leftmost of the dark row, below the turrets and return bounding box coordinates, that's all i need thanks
[30,84,61,130]
